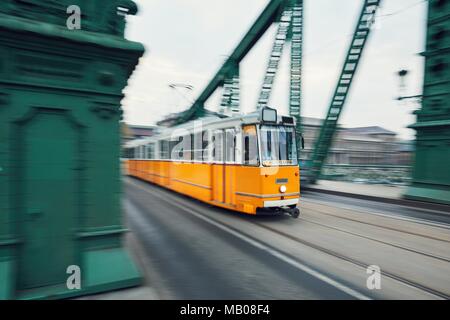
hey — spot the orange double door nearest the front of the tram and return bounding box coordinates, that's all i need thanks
[212,129,236,204]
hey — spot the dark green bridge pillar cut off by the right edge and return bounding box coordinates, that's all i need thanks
[405,0,450,204]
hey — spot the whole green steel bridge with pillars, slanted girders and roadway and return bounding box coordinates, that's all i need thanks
[0,0,450,299]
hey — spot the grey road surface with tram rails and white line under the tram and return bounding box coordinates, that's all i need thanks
[83,178,450,299]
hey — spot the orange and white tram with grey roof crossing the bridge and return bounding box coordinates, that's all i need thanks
[124,108,300,217]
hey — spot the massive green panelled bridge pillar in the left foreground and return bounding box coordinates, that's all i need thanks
[0,0,144,299]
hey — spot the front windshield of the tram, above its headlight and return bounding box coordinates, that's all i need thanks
[260,125,298,167]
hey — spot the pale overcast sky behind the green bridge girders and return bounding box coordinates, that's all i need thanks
[123,0,427,139]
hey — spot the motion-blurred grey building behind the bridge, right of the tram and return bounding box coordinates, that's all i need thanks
[300,118,414,184]
